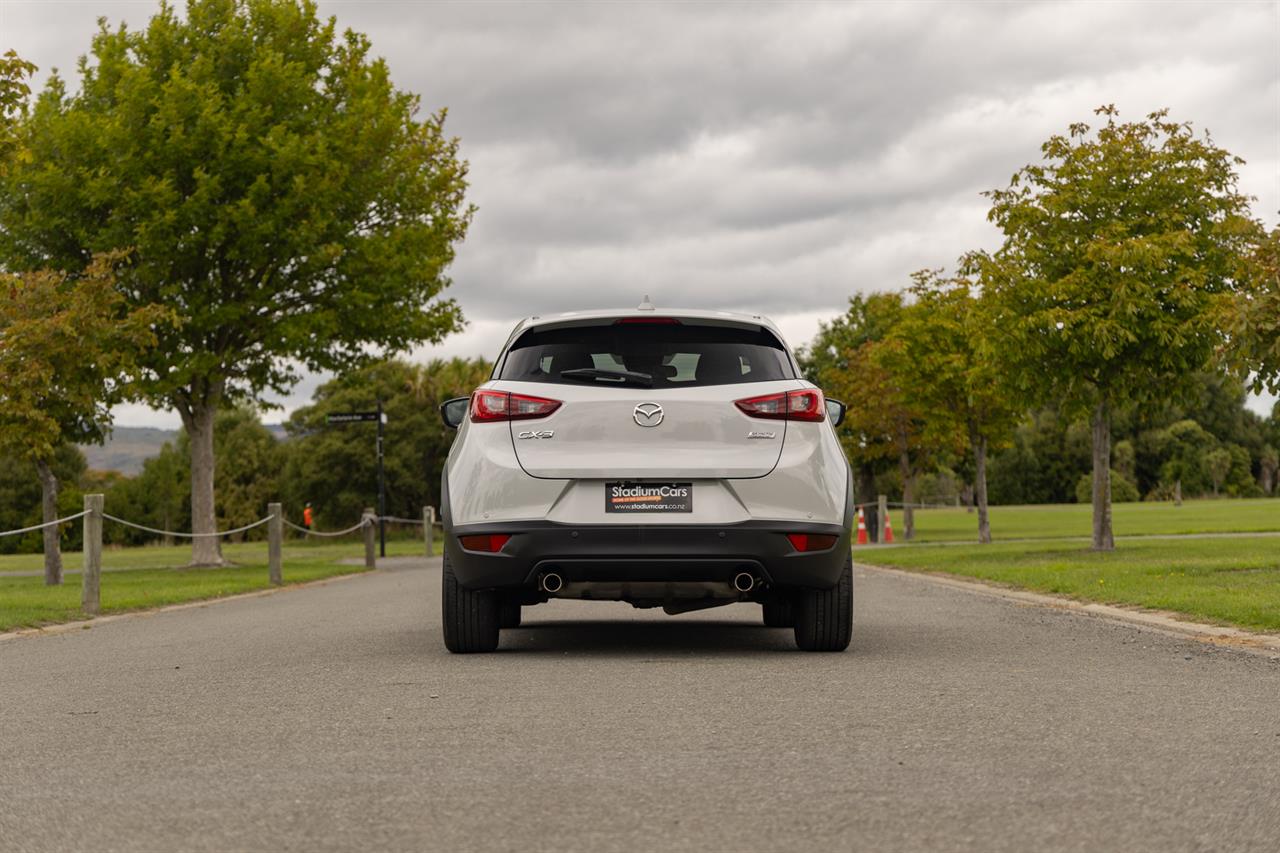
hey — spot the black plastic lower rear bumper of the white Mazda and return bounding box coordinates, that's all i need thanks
[444,521,851,589]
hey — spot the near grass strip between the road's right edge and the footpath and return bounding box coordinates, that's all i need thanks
[854,537,1280,631]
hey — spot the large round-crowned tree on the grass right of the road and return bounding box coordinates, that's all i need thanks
[970,106,1258,549]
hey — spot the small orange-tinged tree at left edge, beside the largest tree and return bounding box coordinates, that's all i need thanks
[0,256,172,584]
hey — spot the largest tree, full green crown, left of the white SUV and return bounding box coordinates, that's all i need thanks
[0,0,472,565]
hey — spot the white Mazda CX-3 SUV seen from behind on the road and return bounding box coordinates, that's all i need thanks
[440,300,854,652]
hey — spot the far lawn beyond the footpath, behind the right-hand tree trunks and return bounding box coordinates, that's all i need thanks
[906,498,1280,542]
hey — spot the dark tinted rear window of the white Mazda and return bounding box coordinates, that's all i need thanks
[498,323,795,388]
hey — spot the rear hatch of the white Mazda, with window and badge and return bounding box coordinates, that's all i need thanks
[489,318,800,480]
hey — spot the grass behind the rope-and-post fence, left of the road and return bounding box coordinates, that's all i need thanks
[0,539,439,631]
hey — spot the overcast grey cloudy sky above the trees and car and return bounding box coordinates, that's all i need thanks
[0,0,1280,425]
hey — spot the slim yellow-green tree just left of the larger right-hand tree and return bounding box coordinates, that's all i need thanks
[890,270,1023,544]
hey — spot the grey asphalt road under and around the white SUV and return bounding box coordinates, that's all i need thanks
[0,555,1280,853]
